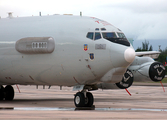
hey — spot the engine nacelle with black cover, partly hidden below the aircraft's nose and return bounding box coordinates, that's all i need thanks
[97,70,134,89]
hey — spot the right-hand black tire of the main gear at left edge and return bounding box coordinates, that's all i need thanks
[4,85,14,100]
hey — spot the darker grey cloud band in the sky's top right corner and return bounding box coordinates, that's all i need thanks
[105,0,167,14]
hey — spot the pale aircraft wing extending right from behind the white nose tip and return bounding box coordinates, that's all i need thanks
[136,51,161,59]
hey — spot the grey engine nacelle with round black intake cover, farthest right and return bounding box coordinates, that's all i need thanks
[128,57,165,82]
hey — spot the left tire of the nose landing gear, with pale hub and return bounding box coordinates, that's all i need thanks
[74,92,85,107]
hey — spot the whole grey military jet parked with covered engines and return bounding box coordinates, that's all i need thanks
[0,15,165,107]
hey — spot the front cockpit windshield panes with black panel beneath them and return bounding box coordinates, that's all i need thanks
[102,32,130,46]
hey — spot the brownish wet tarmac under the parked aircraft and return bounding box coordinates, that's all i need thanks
[0,83,167,120]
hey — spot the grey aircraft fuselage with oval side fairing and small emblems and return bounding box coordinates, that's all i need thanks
[0,15,132,86]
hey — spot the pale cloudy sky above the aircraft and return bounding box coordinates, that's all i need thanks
[0,0,167,49]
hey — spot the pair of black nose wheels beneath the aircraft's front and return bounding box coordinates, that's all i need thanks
[74,90,94,107]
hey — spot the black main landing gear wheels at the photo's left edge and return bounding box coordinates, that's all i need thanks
[0,85,14,100]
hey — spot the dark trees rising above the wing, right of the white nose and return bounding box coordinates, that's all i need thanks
[136,40,153,52]
